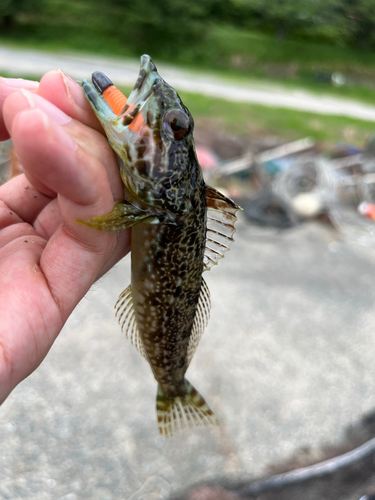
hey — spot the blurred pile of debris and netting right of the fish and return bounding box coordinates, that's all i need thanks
[197,129,375,244]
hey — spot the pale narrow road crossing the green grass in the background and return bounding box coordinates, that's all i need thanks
[0,45,375,121]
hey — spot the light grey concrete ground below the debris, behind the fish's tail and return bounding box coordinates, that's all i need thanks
[0,218,375,500]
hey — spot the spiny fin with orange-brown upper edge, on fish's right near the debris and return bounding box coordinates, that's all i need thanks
[203,186,241,271]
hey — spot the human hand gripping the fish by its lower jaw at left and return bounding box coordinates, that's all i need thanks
[0,71,130,404]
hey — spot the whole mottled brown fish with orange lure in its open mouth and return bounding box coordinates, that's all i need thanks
[79,55,240,437]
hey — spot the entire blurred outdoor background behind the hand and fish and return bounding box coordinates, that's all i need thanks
[0,0,375,500]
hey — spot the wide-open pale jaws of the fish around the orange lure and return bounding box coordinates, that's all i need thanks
[82,54,161,125]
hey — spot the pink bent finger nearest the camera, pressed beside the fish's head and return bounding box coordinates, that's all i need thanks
[12,109,108,207]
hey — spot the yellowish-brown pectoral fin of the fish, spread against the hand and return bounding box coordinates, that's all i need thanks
[77,200,159,231]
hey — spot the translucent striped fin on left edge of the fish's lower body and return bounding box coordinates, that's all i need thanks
[115,285,147,359]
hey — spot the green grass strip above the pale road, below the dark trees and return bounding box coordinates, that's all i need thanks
[0,21,375,109]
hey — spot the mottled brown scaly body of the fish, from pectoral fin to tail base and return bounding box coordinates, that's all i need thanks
[132,183,206,396]
